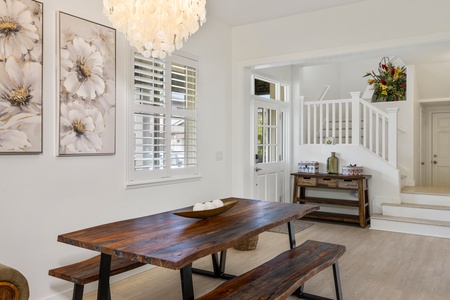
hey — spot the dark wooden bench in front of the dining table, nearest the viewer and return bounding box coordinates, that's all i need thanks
[197,241,345,300]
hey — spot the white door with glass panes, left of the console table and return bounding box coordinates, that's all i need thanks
[253,100,285,202]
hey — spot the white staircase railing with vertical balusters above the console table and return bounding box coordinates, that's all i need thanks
[300,92,398,167]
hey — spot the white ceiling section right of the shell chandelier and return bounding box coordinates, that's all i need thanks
[206,0,367,27]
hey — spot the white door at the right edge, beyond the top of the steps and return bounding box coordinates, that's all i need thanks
[431,113,450,187]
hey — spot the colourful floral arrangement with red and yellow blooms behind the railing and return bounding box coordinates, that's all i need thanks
[363,57,406,102]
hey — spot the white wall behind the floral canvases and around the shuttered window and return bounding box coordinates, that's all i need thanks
[0,0,231,299]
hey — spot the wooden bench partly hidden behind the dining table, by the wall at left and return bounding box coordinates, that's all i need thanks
[48,255,145,300]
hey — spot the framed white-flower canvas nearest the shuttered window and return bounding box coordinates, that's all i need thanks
[58,12,116,155]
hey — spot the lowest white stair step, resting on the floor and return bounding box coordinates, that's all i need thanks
[370,214,450,239]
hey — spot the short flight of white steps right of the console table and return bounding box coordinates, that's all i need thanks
[370,192,450,238]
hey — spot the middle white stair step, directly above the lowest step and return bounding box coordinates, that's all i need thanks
[381,203,450,221]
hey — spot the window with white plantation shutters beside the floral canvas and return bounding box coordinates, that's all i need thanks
[128,53,198,185]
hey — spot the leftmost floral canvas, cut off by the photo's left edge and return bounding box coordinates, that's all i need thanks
[0,0,43,154]
